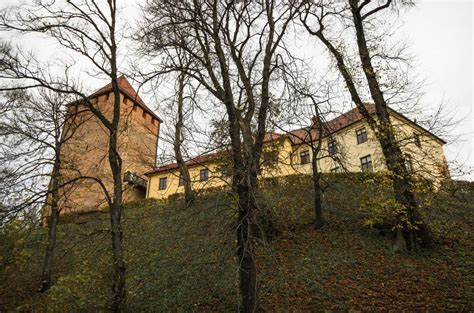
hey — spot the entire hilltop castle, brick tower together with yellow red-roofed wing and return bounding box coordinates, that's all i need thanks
[54,76,449,213]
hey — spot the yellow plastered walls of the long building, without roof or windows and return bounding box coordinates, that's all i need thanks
[147,114,446,199]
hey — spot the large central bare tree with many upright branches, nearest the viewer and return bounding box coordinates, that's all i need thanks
[136,0,297,312]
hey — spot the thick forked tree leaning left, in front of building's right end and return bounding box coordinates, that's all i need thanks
[301,0,433,251]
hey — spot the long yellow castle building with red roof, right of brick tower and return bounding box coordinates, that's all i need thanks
[146,105,449,199]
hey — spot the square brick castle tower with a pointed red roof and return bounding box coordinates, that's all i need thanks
[56,76,162,214]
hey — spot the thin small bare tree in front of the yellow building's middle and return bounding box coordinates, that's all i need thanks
[272,65,345,229]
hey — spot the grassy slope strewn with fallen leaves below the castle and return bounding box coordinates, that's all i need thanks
[0,175,474,312]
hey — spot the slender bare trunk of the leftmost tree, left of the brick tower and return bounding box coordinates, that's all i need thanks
[39,152,60,292]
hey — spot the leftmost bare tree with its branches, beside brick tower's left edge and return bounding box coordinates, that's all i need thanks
[0,89,89,291]
